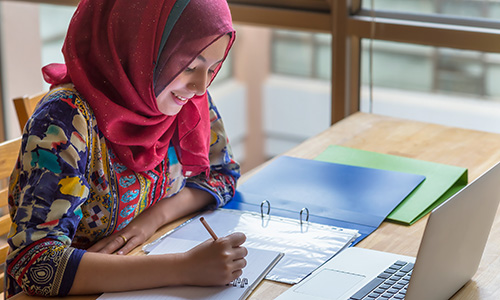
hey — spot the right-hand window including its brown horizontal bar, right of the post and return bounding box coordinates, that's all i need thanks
[354,0,500,132]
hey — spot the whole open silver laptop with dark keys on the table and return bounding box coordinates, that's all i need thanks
[276,163,500,300]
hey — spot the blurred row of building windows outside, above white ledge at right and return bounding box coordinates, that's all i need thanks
[362,40,500,99]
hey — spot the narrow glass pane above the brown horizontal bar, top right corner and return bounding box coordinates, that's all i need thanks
[363,0,500,19]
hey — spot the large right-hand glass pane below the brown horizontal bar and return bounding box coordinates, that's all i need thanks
[361,41,500,132]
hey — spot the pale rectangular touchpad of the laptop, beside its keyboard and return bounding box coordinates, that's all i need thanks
[294,269,365,299]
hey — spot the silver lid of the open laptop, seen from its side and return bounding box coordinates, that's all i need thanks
[405,163,500,300]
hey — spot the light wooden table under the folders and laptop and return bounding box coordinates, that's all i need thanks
[13,113,500,300]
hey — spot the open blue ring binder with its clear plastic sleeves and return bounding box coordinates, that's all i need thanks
[143,156,425,284]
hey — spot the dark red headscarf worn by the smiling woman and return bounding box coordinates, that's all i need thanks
[42,0,235,176]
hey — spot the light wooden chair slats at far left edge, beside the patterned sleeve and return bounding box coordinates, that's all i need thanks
[0,137,21,292]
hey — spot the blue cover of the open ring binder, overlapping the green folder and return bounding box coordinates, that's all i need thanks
[224,156,425,244]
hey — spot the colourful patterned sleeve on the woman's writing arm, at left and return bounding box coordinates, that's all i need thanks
[6,92,89,296]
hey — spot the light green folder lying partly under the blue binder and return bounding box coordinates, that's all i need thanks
[316,146,467,225]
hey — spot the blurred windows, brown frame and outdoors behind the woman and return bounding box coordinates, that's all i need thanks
[0,0,500,171]
